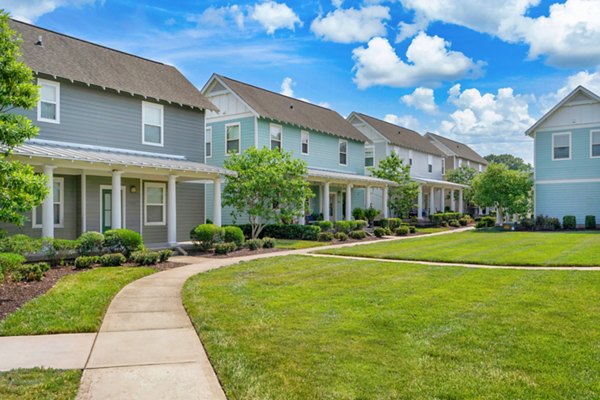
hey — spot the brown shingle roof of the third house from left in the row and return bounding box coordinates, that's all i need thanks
[350,111,443,156]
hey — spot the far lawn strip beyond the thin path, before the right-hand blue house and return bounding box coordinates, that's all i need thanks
[319,230,600,266]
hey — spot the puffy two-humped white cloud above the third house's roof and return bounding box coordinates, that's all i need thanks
[353,32,483,88]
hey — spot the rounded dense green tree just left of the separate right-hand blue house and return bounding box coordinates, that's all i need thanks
[471,163,533,222]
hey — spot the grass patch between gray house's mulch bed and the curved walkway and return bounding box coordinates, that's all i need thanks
[0,267,156,336]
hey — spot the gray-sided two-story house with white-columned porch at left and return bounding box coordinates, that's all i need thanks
[0,21,226,245]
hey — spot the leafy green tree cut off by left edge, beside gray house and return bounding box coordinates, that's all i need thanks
[0,10,47,225]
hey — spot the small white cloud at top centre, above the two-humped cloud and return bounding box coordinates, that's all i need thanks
[310,3,390,43]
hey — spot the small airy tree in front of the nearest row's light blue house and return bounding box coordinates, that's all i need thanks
[223,147,314,239]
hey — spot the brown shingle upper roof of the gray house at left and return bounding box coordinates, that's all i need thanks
[9,20,216,110]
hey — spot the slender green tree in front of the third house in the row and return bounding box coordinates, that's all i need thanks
[370,152,419,217]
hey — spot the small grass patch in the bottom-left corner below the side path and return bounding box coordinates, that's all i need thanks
[0,368,81,400]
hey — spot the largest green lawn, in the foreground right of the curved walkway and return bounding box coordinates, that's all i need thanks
[183,256,600,400]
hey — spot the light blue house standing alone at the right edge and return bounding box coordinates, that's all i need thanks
[526,86,600,226]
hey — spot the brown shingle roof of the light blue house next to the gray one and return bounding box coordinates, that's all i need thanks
[216,75,370,142]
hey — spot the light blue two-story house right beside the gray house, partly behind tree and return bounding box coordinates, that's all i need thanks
[202,74,390,223]
